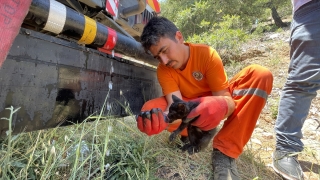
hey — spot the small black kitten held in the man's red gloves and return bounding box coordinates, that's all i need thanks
[167,95,216,154]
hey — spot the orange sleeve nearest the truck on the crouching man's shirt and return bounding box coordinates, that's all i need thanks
[157,64,179,96]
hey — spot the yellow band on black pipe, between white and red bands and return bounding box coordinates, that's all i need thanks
[78,16,97,44]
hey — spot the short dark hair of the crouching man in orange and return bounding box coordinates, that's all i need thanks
[140,16,179,52]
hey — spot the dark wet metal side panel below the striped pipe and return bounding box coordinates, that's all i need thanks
[0,29,161,135]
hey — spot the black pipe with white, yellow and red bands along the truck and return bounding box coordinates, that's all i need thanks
[27,0,158,66]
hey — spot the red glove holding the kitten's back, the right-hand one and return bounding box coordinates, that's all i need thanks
[187,96,228,131]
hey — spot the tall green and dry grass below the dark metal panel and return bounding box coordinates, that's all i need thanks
[0,102,280,179]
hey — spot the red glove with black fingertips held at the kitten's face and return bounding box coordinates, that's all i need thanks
[137,108,168,136]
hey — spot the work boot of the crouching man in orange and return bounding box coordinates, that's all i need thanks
[212,149,240,180]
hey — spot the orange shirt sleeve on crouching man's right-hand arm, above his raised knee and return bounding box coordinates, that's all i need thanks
[205,47,229,92]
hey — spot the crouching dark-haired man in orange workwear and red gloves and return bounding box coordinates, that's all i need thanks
[137,17,273,179]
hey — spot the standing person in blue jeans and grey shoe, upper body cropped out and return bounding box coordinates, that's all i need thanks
[273,0,320,179]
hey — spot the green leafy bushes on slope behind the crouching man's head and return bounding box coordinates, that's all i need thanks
[161,0,291,37]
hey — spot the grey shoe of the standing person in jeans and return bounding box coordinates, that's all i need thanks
[272,150,303,180]
